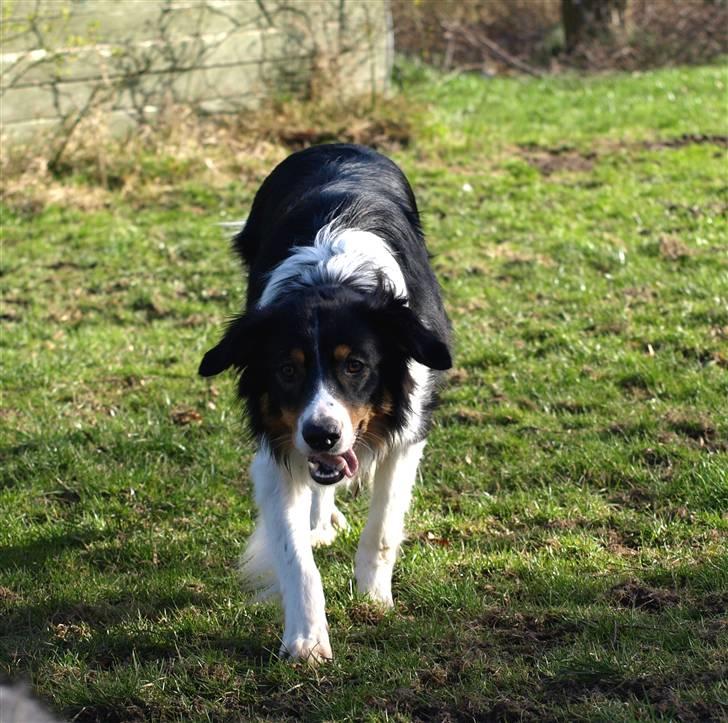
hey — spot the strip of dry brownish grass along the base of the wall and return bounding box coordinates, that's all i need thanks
[0,90,416,214]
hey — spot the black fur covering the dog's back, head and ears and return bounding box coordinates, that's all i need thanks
[200,144,451,446]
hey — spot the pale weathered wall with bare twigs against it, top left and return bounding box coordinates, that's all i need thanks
[0,0,392,137]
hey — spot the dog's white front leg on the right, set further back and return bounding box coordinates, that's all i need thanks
[356,441,425,607]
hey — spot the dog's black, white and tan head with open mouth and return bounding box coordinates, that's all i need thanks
[200,287,451,484]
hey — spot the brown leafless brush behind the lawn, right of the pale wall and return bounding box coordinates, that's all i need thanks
[392,0,728,73]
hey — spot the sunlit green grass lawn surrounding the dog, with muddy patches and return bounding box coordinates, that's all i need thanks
[0,65,728,721]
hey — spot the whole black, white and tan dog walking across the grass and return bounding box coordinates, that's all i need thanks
[200,144,451,661]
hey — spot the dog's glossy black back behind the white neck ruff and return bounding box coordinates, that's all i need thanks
[233,143,450,342]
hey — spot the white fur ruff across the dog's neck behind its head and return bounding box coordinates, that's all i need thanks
[258,220,407,307]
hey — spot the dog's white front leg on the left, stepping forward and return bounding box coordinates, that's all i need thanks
[251,449,332,662]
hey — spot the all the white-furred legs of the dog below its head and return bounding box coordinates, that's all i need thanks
[240,441,425,663]
